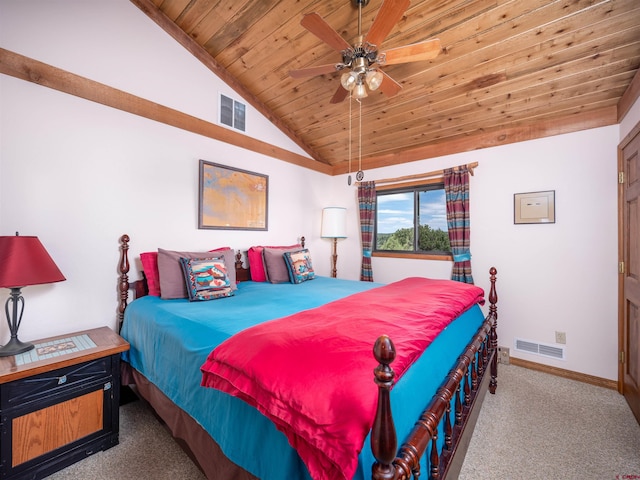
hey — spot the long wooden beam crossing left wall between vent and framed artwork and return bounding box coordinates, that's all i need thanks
[0,48,331,174]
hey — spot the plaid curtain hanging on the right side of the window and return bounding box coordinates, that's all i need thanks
[444,167,473,283]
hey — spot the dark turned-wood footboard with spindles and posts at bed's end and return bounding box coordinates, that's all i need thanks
[371,268,498,480]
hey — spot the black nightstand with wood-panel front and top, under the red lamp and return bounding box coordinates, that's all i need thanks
[0,327,129,480]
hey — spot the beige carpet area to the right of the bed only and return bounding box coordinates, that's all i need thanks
[460,365,640,480]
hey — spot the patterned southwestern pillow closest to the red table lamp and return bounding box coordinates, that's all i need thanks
[180,257,233,302]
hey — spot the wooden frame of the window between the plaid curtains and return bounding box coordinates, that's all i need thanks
[371,176,453,261]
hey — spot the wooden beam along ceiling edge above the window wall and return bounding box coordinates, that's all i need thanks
[332,106,618,175]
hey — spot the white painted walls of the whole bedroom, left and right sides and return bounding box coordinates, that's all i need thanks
[0,0,638,379]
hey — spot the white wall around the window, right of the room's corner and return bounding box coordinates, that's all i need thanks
[324,126,619,379]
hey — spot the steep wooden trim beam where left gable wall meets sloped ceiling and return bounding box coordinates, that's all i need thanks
[131,0,329,164]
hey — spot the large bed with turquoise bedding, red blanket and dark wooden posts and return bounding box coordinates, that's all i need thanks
[118,235,498,480]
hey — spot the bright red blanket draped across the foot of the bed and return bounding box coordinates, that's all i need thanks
[201,278,484,480]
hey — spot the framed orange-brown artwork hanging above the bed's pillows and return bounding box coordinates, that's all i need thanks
[198,160,269,230]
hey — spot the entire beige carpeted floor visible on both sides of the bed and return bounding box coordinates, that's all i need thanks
[49,365,640,480]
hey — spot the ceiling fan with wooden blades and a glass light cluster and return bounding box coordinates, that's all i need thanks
[289,0,441,103]
